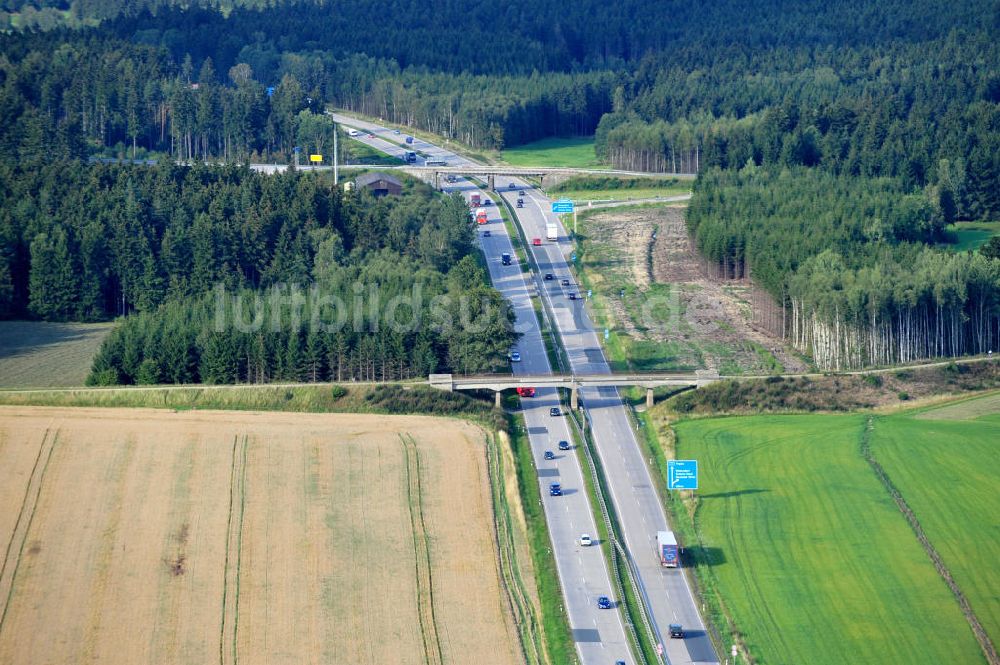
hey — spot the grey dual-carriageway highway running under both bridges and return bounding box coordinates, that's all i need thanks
[334,116,718,665]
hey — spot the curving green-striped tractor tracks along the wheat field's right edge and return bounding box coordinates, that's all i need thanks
[485,434,544,665]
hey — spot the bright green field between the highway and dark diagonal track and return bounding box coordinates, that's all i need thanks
[676,415,984,665]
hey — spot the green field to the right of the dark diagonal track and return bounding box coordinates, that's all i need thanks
[871,395,1000,644]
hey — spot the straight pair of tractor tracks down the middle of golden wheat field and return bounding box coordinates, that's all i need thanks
[219,434,249,665]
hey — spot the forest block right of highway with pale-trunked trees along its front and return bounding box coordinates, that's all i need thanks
[688,167,1000,369]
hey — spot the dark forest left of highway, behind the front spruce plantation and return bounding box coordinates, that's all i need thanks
[0,162,474,320]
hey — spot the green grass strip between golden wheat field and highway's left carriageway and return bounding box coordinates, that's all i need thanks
[508,410,576,663]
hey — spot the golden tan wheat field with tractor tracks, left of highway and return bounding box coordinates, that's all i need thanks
[0,407,521,665]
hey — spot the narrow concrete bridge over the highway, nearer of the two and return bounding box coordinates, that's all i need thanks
[427,370,719,409]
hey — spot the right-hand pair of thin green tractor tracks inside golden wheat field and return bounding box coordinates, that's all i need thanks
[399,434,444,665]
